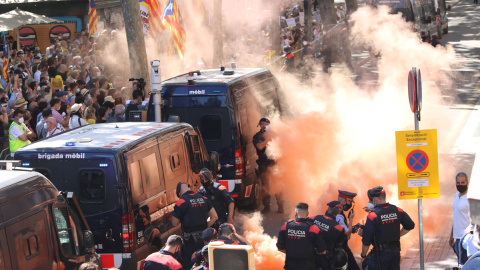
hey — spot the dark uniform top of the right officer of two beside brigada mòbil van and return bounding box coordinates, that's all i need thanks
[198,183,234,224]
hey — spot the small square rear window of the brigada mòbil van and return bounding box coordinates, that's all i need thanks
[78,169,106,203]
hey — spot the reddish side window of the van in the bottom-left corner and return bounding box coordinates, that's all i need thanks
[6,211,52,269]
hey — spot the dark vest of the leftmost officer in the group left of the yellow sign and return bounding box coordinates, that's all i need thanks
[286,220,315,260]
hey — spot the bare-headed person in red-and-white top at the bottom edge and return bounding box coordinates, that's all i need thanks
[143,235,183,270]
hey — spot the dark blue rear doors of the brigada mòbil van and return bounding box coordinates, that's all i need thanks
[16,150,124,253]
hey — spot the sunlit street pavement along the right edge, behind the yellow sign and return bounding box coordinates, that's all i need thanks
[401,0,480,270]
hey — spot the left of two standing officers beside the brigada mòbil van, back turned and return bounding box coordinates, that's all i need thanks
[172,182,218,269]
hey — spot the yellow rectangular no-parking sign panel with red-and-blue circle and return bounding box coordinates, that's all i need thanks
[395,129,440,200]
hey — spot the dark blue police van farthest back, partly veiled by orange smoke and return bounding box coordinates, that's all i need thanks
[147,68,286,208]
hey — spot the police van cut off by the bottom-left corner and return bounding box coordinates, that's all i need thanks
[0,170,101,270]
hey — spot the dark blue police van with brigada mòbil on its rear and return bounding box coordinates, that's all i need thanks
[15,122,218,269]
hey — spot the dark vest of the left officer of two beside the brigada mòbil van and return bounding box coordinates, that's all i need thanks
[182,194,208,233]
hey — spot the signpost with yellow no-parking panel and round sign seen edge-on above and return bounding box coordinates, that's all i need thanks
[395,68,440,270]
